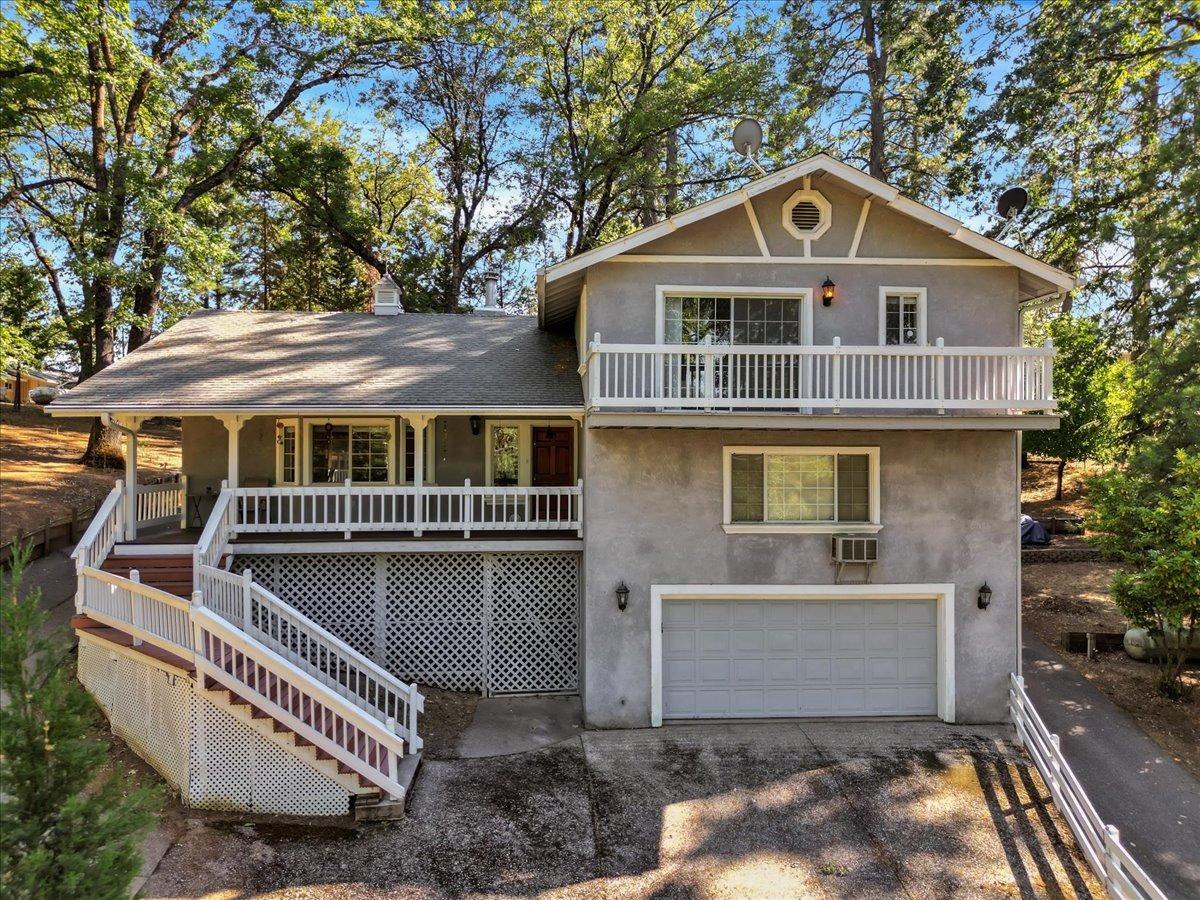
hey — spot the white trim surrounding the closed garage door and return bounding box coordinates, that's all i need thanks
[649,583,955,728]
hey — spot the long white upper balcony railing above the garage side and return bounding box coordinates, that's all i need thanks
[586,335,1055,413]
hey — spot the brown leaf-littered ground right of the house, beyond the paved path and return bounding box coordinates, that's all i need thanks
[1021,562,1200,778]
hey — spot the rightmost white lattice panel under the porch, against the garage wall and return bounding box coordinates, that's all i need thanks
[487,553,580,694]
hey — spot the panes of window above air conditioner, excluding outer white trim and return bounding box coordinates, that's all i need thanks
[727,448,872,524]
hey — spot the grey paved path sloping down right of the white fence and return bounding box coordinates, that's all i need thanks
[1022,635,1200,899]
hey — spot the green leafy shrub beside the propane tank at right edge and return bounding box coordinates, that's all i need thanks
[1088,450,1200,698]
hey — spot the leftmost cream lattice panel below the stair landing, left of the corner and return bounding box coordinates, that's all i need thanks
[79,637,192,793]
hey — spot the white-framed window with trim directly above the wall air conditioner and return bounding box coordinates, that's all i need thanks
[725,446,880,532]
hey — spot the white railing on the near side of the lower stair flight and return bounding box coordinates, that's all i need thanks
[192,606,404,799]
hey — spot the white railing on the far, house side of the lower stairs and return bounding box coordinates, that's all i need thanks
[198,565,425,752]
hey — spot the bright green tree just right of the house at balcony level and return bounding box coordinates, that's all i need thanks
[1022,314,1127,472]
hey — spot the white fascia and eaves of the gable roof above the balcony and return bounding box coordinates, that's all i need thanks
[538,154,1075,325]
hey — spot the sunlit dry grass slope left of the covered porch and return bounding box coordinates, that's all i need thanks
[0,406,180,540]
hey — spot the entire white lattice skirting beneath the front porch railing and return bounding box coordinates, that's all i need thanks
[234,552,580,695]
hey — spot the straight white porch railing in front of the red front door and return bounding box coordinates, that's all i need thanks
[231,480,583,538]
